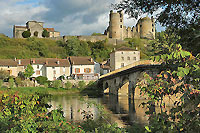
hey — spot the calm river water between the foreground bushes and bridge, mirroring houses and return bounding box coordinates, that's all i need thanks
[49,95,156,127]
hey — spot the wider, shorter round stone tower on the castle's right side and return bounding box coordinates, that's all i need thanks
[137,17,155,39]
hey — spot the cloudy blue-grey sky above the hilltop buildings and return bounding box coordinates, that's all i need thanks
[0,0,164,37]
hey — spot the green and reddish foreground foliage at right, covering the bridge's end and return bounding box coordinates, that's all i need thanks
[139,34,200,132]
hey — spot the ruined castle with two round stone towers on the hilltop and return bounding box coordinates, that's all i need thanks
[104,10,155,40]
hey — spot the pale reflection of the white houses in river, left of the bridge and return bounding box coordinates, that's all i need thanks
[49,95,100,121]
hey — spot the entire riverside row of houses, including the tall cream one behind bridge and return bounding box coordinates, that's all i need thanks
[0,47,140,80]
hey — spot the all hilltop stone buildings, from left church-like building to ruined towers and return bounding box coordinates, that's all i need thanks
[13,10,155,45]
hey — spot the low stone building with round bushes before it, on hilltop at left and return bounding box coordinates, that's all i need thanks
[13,21,60,38]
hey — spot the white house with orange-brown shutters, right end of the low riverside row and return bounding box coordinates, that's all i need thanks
[69,56,99,80]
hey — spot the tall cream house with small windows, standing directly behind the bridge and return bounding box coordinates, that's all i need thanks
[110,47,140,71]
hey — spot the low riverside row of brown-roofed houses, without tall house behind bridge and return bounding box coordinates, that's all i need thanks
[0,57,99,81]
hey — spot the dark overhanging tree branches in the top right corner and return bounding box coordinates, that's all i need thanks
[114,0,200,55]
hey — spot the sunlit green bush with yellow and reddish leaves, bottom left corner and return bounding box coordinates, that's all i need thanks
[0,92,82,132]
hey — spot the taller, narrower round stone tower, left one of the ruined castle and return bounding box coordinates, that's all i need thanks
[109,10,124,40]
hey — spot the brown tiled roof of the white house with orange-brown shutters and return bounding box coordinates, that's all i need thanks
[69,56,94,65]
